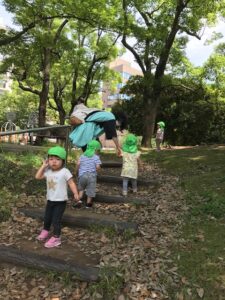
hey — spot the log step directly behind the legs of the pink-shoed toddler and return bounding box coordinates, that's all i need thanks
[20,208,138,232]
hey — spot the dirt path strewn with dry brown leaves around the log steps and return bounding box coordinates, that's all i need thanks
[0,161,186,300]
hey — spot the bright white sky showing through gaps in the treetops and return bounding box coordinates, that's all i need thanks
[0,0,225,66]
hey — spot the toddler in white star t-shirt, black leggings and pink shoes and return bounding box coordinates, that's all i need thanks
[35,146,79,248]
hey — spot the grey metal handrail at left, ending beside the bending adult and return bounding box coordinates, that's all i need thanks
[0,125,71,159]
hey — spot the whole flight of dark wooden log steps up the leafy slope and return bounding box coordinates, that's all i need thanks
[0,154,156,282]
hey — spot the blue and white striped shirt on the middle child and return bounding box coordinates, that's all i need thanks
[78,154,102,177]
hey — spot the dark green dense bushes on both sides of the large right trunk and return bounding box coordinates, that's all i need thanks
[112,76,225,145]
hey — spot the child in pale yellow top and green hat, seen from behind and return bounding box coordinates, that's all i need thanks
[121,134,141,197]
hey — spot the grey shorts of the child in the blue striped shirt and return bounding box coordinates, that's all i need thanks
[78,173,97,198]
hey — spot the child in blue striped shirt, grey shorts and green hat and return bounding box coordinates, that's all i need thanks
[74,140,102,208]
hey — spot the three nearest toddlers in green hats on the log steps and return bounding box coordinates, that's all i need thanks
[35,120,165,248]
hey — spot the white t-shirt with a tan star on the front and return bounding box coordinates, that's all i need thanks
[44,168,73,201]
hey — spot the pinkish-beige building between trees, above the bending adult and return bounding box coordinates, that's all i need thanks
[102,58,142,108]
